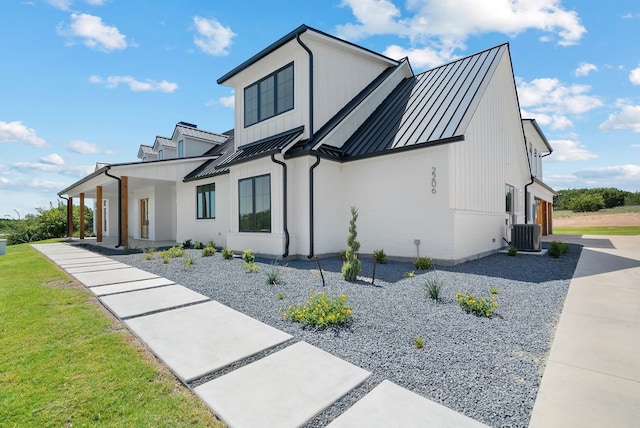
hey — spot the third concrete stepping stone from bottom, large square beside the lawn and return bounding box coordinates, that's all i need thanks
[125,301,291,382]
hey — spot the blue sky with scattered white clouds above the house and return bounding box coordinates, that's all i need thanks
[0,0,640,214]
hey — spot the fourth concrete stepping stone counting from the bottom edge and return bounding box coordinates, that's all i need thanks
[100,284,209,318]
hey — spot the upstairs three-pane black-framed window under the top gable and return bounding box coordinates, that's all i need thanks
[244,63,293,127]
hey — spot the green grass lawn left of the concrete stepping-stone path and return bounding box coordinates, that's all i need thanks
[0,245,224,427]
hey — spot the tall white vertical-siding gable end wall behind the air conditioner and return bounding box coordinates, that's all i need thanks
[448,50,530,260]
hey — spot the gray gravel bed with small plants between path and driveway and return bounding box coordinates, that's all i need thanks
[105,245,581,427]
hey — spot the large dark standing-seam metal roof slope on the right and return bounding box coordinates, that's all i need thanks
[342,45,507,158]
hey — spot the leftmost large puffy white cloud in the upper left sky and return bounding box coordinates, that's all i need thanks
[58,13,127,52]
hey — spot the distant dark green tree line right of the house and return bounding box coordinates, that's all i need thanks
[553,187,640,212]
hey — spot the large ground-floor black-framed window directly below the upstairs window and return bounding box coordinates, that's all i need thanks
[238,174,271,233]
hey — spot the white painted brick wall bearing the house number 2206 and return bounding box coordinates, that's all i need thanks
[315,146,453,259]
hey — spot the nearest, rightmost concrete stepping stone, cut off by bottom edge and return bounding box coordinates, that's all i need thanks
[327,380,488,428]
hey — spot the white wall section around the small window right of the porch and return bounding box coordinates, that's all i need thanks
[176,174,232,247]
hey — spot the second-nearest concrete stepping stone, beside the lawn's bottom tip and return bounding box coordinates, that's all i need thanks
[194,342,372,428]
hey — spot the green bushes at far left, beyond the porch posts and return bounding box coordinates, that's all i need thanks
[0,201,93,245]
